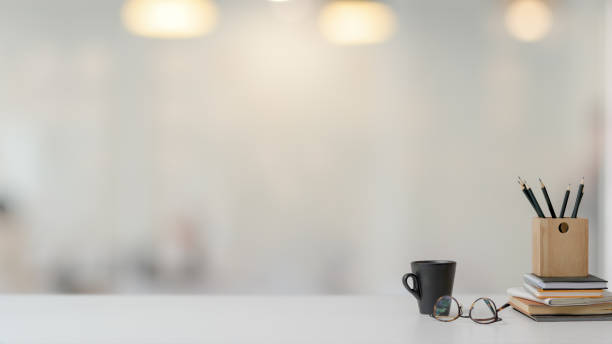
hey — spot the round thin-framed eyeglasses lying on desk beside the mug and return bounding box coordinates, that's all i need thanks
[431,295,510,324]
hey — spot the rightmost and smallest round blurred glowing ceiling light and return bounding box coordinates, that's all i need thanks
[506,0,552,42]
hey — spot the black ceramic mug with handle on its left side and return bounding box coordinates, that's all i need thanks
[402,260,457,314]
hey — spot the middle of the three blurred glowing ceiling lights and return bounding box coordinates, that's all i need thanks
[319,0,395,45]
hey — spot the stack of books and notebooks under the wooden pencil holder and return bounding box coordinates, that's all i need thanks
[508,274,612,321]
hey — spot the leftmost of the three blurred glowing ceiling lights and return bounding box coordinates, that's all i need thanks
[121,0,217,38]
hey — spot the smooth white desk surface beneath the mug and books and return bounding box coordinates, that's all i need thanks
[0,295,612,344]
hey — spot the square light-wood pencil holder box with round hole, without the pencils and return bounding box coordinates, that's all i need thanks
[532,218,589,277]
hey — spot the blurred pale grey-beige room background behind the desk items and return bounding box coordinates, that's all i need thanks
[0,0,612,294]
